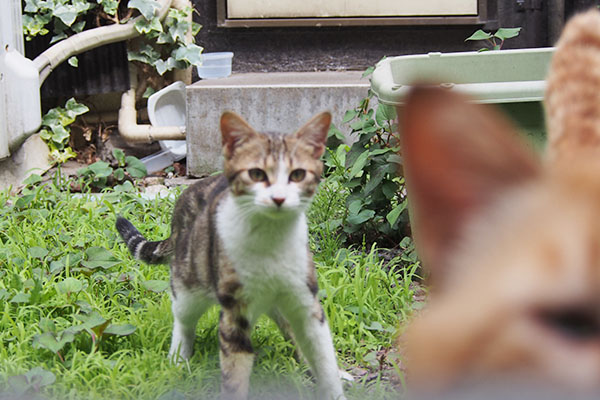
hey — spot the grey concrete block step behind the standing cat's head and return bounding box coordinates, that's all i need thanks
[186,71,370,176]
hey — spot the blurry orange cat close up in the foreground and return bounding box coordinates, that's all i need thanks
[399,11,600,398]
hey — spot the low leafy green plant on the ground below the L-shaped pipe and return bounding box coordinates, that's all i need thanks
[77,149,148,190]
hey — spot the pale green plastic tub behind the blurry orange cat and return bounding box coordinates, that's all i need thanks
[371,47,554,147]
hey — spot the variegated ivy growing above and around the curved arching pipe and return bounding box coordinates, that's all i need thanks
[23,0,202,76]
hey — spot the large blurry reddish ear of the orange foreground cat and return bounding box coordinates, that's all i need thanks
[398,86,541,281]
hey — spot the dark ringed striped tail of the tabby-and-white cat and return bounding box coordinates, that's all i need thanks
[115,217,173,264]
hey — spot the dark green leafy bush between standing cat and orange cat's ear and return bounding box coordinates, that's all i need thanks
[325,69,408,247]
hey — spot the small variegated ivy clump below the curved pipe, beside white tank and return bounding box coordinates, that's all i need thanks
[39,98,89,163]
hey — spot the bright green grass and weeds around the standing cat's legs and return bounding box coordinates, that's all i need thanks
[0,177,415,399]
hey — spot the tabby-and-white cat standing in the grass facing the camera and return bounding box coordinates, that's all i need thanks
[116,112,344,400]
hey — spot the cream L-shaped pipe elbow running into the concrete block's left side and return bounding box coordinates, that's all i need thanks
[119,0,191,143]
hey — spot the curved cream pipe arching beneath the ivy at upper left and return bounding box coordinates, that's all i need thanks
[33,0,172,85]
